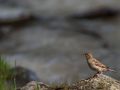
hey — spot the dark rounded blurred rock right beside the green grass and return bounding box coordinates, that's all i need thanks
[11,66,39,87]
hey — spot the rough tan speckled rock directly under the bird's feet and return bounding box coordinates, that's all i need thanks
[70,75,120,90]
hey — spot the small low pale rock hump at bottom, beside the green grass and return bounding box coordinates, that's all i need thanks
[18,81,49,90]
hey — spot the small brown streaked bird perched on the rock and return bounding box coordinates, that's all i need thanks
[84,52,114,75]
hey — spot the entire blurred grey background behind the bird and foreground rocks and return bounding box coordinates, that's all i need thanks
[0,0,120,83]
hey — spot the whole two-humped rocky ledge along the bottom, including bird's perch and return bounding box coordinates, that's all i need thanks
[19,75,120,90]
